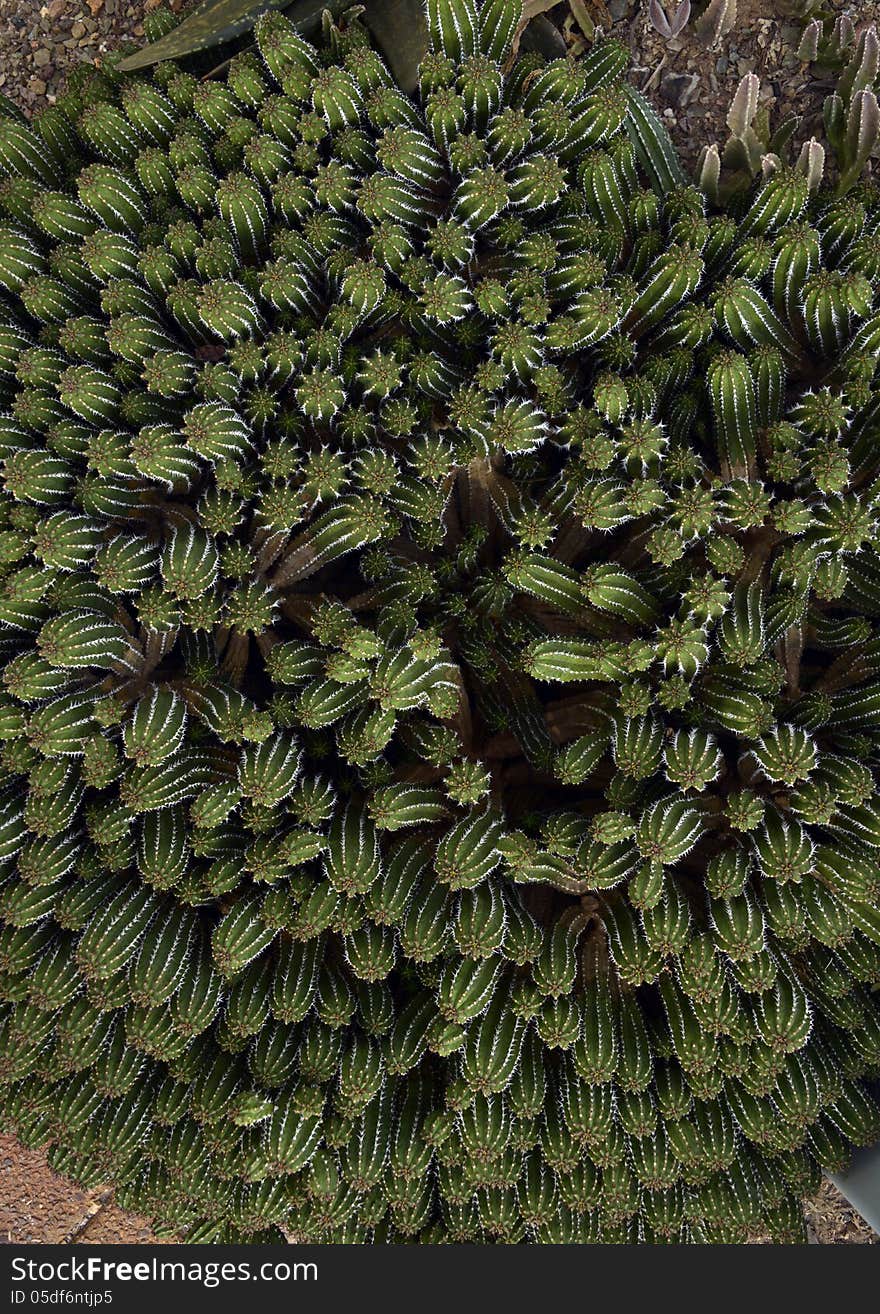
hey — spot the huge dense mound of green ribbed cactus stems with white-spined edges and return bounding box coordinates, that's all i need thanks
[0,0,880,1243]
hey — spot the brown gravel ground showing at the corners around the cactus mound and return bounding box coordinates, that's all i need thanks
[0,0,880,1244]
